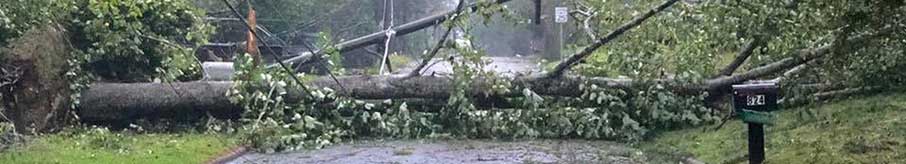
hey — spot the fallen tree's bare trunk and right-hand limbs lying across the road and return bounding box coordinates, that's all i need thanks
[79,0,867,120]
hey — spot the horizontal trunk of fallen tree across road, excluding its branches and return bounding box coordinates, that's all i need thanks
[78,76,692,122]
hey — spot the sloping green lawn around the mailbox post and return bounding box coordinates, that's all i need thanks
[640,94,906,163]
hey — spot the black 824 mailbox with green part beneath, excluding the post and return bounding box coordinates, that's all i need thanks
[733,82,780,124]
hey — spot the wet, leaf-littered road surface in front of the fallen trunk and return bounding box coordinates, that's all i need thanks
[229,140,645,164]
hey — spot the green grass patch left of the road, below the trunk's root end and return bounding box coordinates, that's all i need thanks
[0,129,237,164]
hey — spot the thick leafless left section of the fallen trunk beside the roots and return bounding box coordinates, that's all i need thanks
[77,82,242,122]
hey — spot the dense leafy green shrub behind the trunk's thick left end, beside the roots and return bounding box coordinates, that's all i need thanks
[71,0,211,81]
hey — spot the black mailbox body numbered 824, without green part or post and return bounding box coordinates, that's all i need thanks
[733,82,780,112]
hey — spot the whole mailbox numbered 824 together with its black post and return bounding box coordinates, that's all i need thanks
[733,82,779,164]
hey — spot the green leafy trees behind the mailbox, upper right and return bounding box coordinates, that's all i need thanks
[574,0,904,103]
